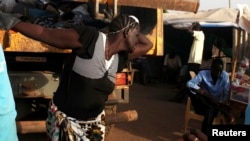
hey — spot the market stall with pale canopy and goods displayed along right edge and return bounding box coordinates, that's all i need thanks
[163,5,250,122]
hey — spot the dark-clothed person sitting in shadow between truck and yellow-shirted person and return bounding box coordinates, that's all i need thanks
[163,51,182,83]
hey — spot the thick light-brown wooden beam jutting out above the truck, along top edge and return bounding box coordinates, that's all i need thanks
[72,0,199,12]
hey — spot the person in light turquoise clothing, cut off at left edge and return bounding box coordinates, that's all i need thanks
[0,45,18,141]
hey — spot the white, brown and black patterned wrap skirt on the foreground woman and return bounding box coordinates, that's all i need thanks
[46,101,105,141]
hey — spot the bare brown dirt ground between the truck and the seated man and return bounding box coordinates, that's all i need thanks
[19,82,200,141]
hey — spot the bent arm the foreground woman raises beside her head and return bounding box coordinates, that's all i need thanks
[128,33,153,60]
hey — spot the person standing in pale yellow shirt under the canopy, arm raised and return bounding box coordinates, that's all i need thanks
[188,22,205,74]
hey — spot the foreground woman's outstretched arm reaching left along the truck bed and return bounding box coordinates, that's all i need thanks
[12,22,82,49]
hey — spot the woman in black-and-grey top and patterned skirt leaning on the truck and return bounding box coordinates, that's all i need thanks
[0,12,153,141]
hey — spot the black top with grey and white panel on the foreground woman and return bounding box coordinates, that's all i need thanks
[53,26,127,120]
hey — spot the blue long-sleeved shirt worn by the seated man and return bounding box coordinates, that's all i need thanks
[187,70,230,102]
